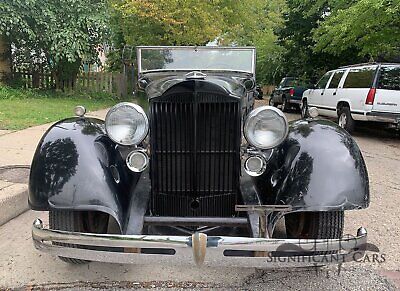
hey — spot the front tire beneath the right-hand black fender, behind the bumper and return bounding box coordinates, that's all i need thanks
[285,211,344,239]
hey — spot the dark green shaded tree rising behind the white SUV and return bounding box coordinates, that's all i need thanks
[275,0,365,83]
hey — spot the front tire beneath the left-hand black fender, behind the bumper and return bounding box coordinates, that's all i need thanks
[49,210,108,264]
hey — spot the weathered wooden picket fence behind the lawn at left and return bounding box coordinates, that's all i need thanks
[13,71,130,97]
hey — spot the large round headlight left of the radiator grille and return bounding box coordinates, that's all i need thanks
[106,102,149,145]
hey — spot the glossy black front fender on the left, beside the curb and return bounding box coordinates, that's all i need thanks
[28,118,140,229]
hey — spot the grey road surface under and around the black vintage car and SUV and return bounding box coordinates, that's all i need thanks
[0,100,400,290]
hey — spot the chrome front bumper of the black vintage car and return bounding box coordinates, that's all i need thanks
[32,219,367,268]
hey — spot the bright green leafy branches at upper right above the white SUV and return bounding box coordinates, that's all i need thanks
[313,0,400,59]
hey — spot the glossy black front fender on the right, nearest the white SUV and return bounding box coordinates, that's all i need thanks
[253,119,369,211]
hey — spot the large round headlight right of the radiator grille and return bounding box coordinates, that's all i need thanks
[244,106,289,149]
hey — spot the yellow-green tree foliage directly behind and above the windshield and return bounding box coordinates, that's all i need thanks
[111,0,285,83]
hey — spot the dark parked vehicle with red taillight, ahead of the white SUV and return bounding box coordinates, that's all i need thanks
[269,77,307,112]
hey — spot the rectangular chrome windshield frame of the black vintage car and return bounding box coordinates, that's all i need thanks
[136,46,256,76]
